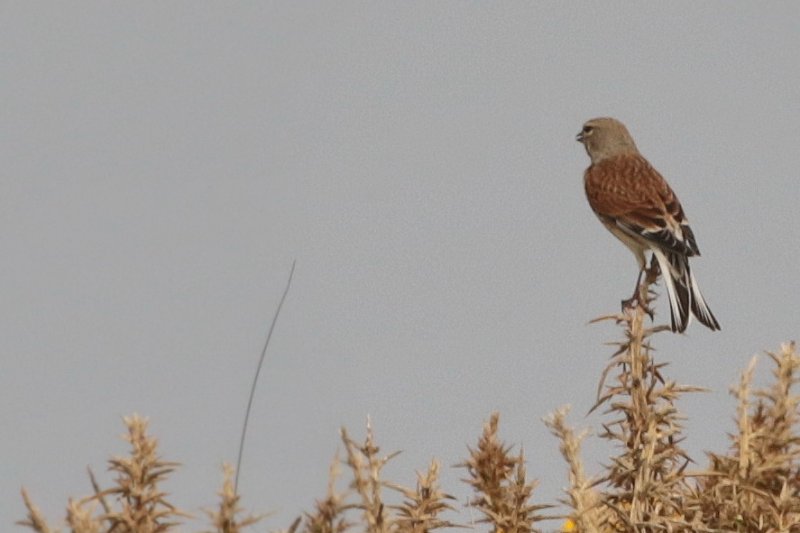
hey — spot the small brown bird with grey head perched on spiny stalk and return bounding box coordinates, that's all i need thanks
[576,117,720,333]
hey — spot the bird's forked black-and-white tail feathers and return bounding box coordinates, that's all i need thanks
[653,250,720,333]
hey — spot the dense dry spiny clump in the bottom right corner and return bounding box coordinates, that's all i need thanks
[691,343,800,531]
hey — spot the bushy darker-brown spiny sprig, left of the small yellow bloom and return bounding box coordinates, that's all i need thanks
[457,413,551,533]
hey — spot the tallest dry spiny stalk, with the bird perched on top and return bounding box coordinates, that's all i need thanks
[592,270,703,531]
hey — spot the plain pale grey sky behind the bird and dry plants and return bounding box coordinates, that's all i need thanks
[0,1,800,531]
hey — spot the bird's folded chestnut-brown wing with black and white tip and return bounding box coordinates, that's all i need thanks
[585,155,700,256]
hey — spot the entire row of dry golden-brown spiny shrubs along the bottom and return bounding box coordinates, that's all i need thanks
[19,280,800,533]
